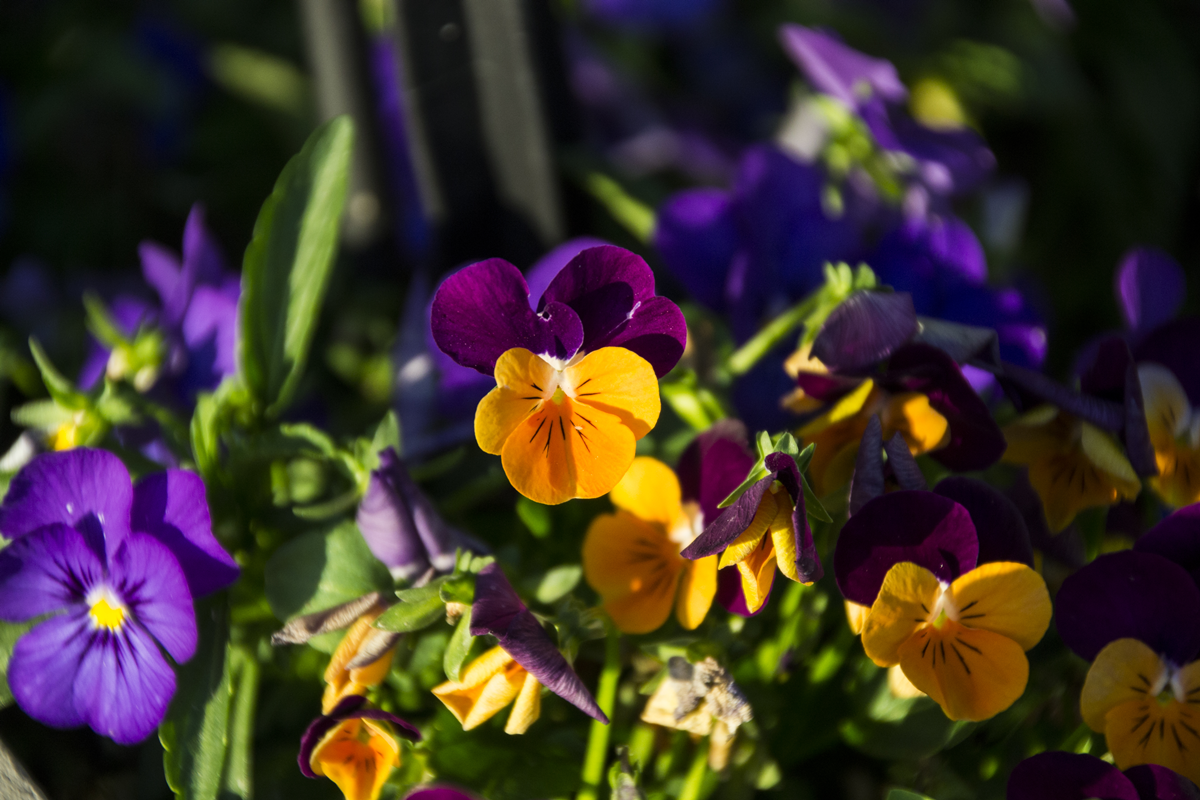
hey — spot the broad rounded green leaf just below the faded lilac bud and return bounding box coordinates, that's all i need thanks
[265,521,392,633]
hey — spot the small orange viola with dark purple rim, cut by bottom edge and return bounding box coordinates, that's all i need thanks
[298,696,421,800]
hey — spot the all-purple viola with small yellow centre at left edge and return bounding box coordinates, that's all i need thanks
[0,449,238,744]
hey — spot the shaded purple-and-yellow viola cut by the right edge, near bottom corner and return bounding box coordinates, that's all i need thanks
[1057,551,1200,781]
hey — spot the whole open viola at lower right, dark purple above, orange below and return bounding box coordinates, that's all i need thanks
[834,479,1051,721]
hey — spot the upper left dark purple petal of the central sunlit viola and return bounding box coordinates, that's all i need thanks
[430,258,583,375]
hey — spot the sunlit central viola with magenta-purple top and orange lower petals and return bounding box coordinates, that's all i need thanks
[432,246,688,504]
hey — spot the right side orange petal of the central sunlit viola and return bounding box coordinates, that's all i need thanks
[563,347,662,441]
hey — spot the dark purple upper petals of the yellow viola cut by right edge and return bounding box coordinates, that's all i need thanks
[1055,551,1200,666]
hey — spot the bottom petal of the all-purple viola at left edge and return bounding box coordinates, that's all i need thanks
[75,621,175,745]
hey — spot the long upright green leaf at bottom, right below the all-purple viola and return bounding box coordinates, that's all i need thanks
[158,593,233,800]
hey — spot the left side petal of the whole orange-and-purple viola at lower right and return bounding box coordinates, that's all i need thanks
[863,561,942,671]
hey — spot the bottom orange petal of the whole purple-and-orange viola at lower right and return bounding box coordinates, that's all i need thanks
[902,610,1030,721]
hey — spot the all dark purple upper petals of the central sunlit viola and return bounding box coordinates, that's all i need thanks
[431,246,686,377]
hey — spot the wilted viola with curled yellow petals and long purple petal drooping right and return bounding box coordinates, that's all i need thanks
[433,564,608,734]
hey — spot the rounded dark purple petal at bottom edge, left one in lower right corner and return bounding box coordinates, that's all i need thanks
[1004,752,1140,800]
